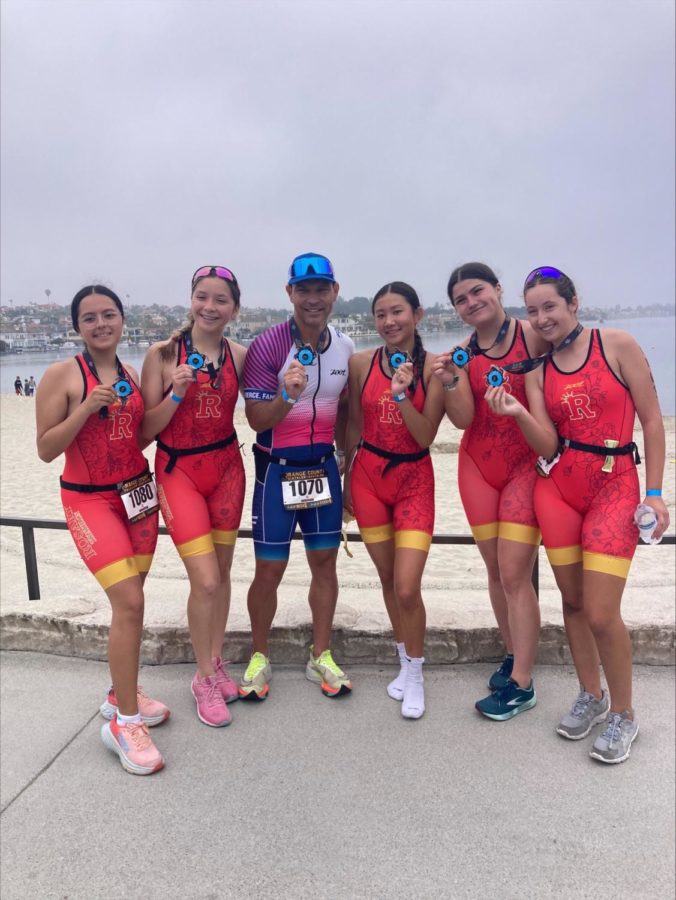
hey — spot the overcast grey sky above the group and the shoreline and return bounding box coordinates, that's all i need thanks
[0,0,674,306]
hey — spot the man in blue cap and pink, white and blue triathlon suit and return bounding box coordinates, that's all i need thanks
[239,253,354,700]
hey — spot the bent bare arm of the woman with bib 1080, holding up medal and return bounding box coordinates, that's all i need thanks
[35,360,117,462]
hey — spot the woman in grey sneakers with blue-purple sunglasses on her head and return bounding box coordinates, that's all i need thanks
[486,266,669,763]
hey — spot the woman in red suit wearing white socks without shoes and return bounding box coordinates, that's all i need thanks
[343,281,444,719]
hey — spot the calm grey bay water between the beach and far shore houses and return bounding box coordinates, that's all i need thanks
[0,316,676,416]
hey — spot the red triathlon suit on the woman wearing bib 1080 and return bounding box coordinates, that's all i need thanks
[61,354,158,590]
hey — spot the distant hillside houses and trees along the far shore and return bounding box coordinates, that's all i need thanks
[0,298,676,353]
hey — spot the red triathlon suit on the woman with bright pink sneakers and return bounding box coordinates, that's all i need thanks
[155,339,245,559]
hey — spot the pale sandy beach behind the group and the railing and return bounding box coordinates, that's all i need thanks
[0,397,675,652]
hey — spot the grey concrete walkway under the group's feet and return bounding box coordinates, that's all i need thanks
[0,652,674,900]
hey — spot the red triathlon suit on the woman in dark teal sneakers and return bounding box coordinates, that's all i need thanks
[458,319,540,546]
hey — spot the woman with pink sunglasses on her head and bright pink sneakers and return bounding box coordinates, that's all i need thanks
[142,266,246,727]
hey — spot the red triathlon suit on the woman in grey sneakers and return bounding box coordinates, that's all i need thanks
[535,329,640,578]
